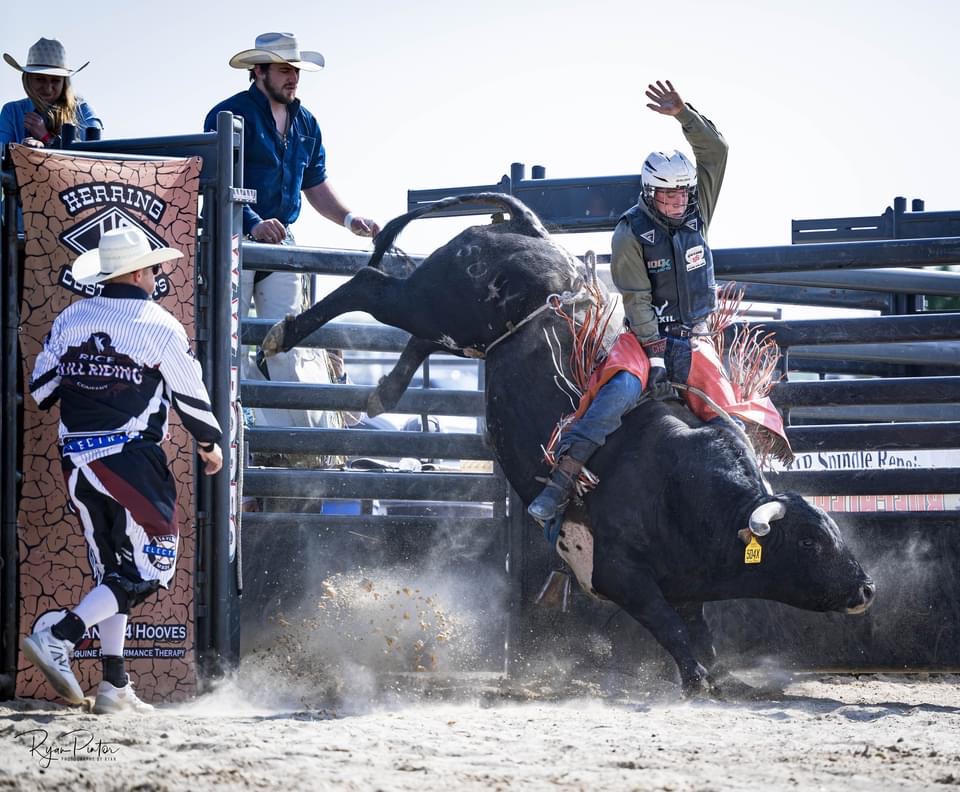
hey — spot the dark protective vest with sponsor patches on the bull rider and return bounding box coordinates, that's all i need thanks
[620,205,717,327]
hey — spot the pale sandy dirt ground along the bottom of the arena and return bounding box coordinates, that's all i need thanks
[0,675,960,792]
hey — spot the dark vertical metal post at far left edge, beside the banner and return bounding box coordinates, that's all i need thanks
[0,170,22,699]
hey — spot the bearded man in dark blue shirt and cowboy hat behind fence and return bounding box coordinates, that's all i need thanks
[203,33,380,434]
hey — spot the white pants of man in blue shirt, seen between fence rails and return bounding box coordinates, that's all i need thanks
[240,271,343,428]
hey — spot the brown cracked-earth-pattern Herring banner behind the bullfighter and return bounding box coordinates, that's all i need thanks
[10,145,201,702]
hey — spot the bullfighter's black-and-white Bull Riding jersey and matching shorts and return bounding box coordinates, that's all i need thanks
[30,283,221,599]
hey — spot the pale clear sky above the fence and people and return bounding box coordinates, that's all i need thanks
[7,0,960,260]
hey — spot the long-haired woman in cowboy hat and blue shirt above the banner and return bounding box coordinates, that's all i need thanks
[0,38,103,148]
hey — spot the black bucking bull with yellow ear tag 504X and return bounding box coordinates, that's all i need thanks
[264,194,874,693]
